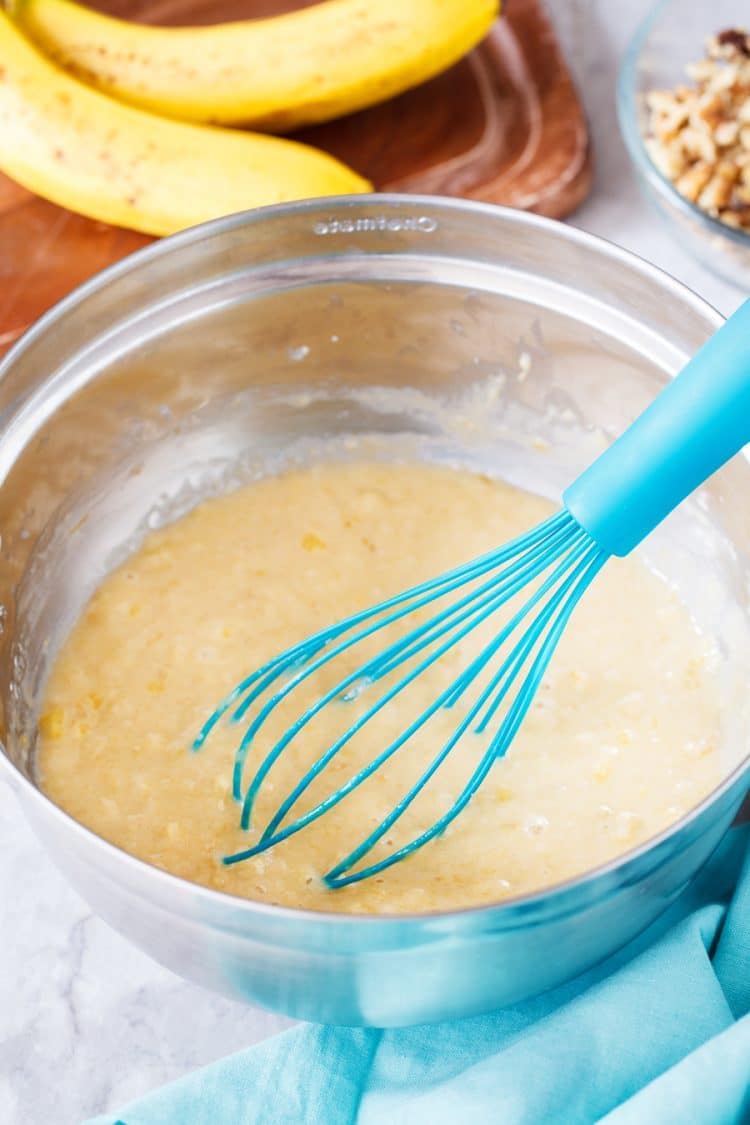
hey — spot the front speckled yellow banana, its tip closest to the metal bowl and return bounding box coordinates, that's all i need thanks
[0,11,370,234]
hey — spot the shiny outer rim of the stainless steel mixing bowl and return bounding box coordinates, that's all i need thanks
[0,192,750,933]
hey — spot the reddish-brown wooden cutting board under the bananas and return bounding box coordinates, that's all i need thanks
[0,0,591,354]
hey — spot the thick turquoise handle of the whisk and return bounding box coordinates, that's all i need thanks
[563,300,750,555]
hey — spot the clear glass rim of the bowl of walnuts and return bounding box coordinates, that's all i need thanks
[616,0,750,250]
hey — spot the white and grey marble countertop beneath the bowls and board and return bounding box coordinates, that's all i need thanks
[0,0,742,1125]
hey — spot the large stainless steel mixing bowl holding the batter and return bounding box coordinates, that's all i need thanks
[0,196,750,1026]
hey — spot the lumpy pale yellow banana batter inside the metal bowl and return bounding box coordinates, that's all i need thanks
[38,461,720,912]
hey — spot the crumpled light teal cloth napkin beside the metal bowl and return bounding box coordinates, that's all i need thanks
[89,826,750,1125]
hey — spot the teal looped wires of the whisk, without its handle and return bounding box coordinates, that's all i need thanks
[193,510,607,888]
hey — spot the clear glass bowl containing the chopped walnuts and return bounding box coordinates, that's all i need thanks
[617,0,750,290]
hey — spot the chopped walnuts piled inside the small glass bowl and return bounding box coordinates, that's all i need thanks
[645,28,750,232]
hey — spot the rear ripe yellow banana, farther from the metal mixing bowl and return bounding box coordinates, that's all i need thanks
[7,0,499,132]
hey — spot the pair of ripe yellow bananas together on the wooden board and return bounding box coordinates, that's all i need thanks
[0,0,498,234]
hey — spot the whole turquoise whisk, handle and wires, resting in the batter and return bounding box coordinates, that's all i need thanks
[193,302,750,888]
